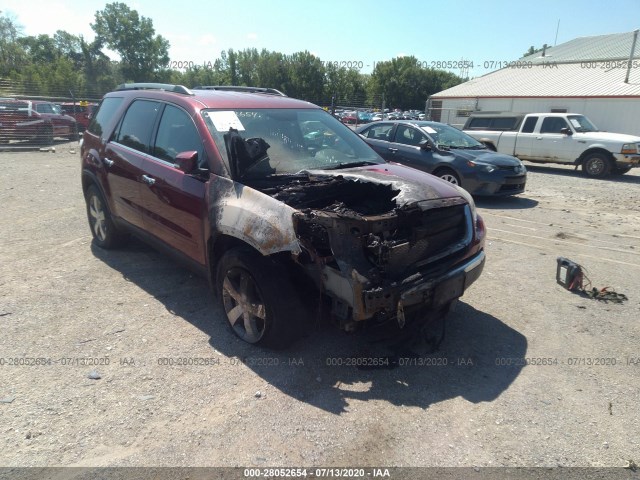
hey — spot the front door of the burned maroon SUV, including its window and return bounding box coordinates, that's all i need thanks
[141,104,207,265]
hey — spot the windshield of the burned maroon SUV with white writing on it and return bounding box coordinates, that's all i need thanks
[202,109,384,179]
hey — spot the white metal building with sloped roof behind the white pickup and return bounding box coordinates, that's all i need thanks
[427,30,640,136]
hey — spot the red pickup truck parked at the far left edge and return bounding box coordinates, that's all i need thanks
[0,99,76,145]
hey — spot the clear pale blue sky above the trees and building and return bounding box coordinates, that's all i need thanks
[0,0,640,77]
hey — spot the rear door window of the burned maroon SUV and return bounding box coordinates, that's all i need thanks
[114,100,162,153]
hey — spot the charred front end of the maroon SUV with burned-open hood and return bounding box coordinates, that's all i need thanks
[262,172,484,329]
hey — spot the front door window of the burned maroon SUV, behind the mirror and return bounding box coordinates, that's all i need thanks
[152,105,203,163]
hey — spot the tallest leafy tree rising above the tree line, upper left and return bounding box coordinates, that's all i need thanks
[91,2,169,82]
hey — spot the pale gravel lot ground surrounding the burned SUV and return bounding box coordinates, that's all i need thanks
[0,144,640,472]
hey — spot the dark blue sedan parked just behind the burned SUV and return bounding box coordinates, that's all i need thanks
[356,120,527,196]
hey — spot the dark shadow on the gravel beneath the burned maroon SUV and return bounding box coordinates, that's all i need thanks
[92,240,527,414]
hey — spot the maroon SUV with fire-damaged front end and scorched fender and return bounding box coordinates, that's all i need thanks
[81,84,485,347]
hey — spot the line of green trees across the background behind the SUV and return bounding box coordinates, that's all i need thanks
[0,2,463,109]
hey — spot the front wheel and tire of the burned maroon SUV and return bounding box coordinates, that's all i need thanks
[216,247,306,349]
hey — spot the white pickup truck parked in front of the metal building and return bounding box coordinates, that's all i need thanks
[463,113,640,177]
